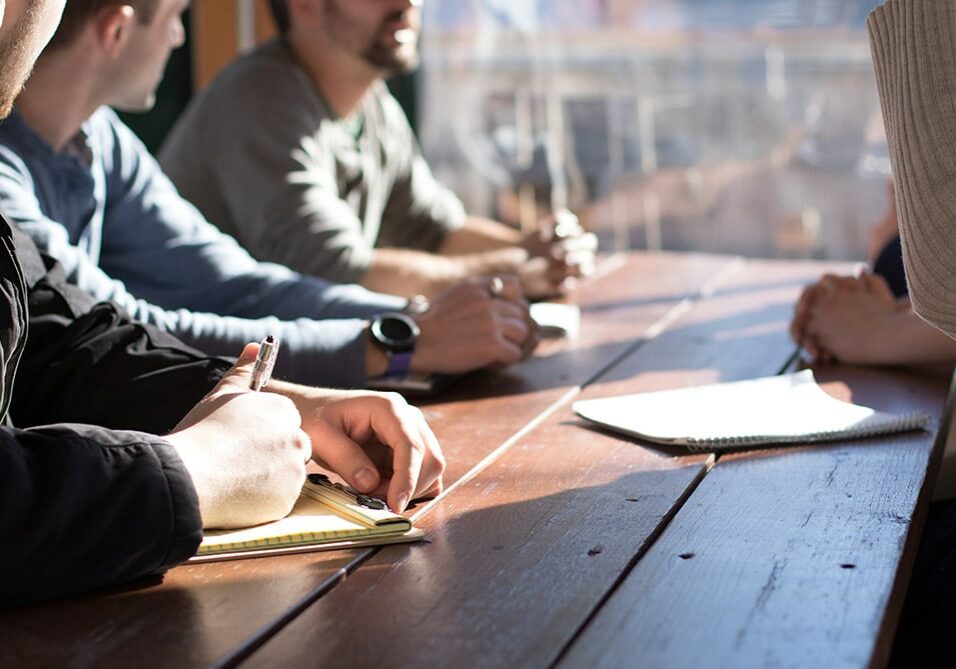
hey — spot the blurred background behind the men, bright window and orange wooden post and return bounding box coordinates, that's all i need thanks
[127,0,889,259]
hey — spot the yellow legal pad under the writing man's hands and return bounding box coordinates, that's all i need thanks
[191,474,424,562]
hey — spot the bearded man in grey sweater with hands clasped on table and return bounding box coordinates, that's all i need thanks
[160,0,595,298]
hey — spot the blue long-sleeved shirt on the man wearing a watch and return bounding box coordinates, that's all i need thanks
[0,107,404,387]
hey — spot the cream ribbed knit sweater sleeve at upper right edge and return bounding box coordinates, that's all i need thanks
[867,0,956,338]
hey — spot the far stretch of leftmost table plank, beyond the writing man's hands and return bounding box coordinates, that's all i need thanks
[422,254,735,485]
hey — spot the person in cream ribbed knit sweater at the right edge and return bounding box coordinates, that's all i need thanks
[867,0,956,666]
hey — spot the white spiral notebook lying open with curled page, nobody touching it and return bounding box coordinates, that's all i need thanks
[573,370,930,451]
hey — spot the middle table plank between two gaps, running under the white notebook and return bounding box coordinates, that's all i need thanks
[248,263,840,667]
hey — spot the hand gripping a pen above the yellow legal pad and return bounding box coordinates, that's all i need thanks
[166,344,311,528]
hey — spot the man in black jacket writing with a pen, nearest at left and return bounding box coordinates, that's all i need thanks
[0,0,444,607]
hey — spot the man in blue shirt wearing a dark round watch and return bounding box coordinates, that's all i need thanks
[0,0,536,387]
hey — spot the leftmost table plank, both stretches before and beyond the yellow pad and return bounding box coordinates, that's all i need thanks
[0,254,732,667]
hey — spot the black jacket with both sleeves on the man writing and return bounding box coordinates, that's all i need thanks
[0,220,229,607]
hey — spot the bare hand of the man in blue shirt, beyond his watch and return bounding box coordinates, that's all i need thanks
[412,276,540,373]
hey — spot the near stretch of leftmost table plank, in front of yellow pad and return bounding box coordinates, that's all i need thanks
[0,550,360,668]
